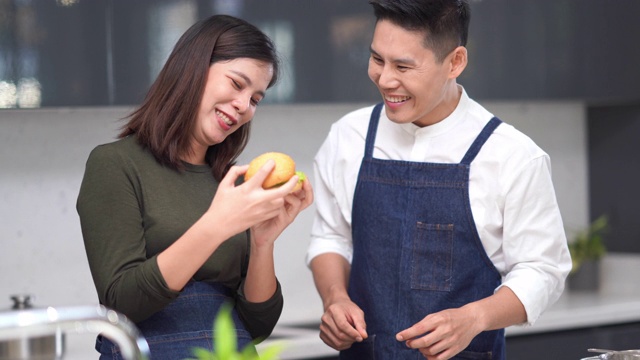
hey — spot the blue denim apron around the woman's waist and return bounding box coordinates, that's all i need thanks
[96,281,253,360]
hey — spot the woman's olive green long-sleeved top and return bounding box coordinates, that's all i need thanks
[77,136,283,338]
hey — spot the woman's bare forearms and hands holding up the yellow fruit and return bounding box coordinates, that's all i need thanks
[158,161,313,292]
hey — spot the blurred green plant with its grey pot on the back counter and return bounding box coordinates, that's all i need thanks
[568,215,609,291]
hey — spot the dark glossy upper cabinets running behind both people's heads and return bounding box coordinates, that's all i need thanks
[0,0,640,108]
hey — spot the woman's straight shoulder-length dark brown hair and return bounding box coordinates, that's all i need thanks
[118,15,279,181]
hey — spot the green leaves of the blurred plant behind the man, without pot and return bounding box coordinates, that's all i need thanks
[569,215,609,273]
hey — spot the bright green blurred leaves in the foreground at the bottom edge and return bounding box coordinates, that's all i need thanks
[185,303,282,360]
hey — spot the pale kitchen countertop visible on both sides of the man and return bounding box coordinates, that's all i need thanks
[258,254,640,360]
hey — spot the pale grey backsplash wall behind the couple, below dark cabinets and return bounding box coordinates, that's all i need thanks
[0,102,589,358]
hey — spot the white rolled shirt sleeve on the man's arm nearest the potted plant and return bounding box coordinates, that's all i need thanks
[502,155,571,325]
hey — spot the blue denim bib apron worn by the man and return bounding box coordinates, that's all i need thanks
[340,104,505,360]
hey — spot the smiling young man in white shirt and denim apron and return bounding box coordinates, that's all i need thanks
[307,0,571,360]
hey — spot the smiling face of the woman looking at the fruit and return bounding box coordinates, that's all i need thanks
[192,58,273,163]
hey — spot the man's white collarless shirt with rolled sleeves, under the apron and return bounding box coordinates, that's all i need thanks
[306,89,571,324]
